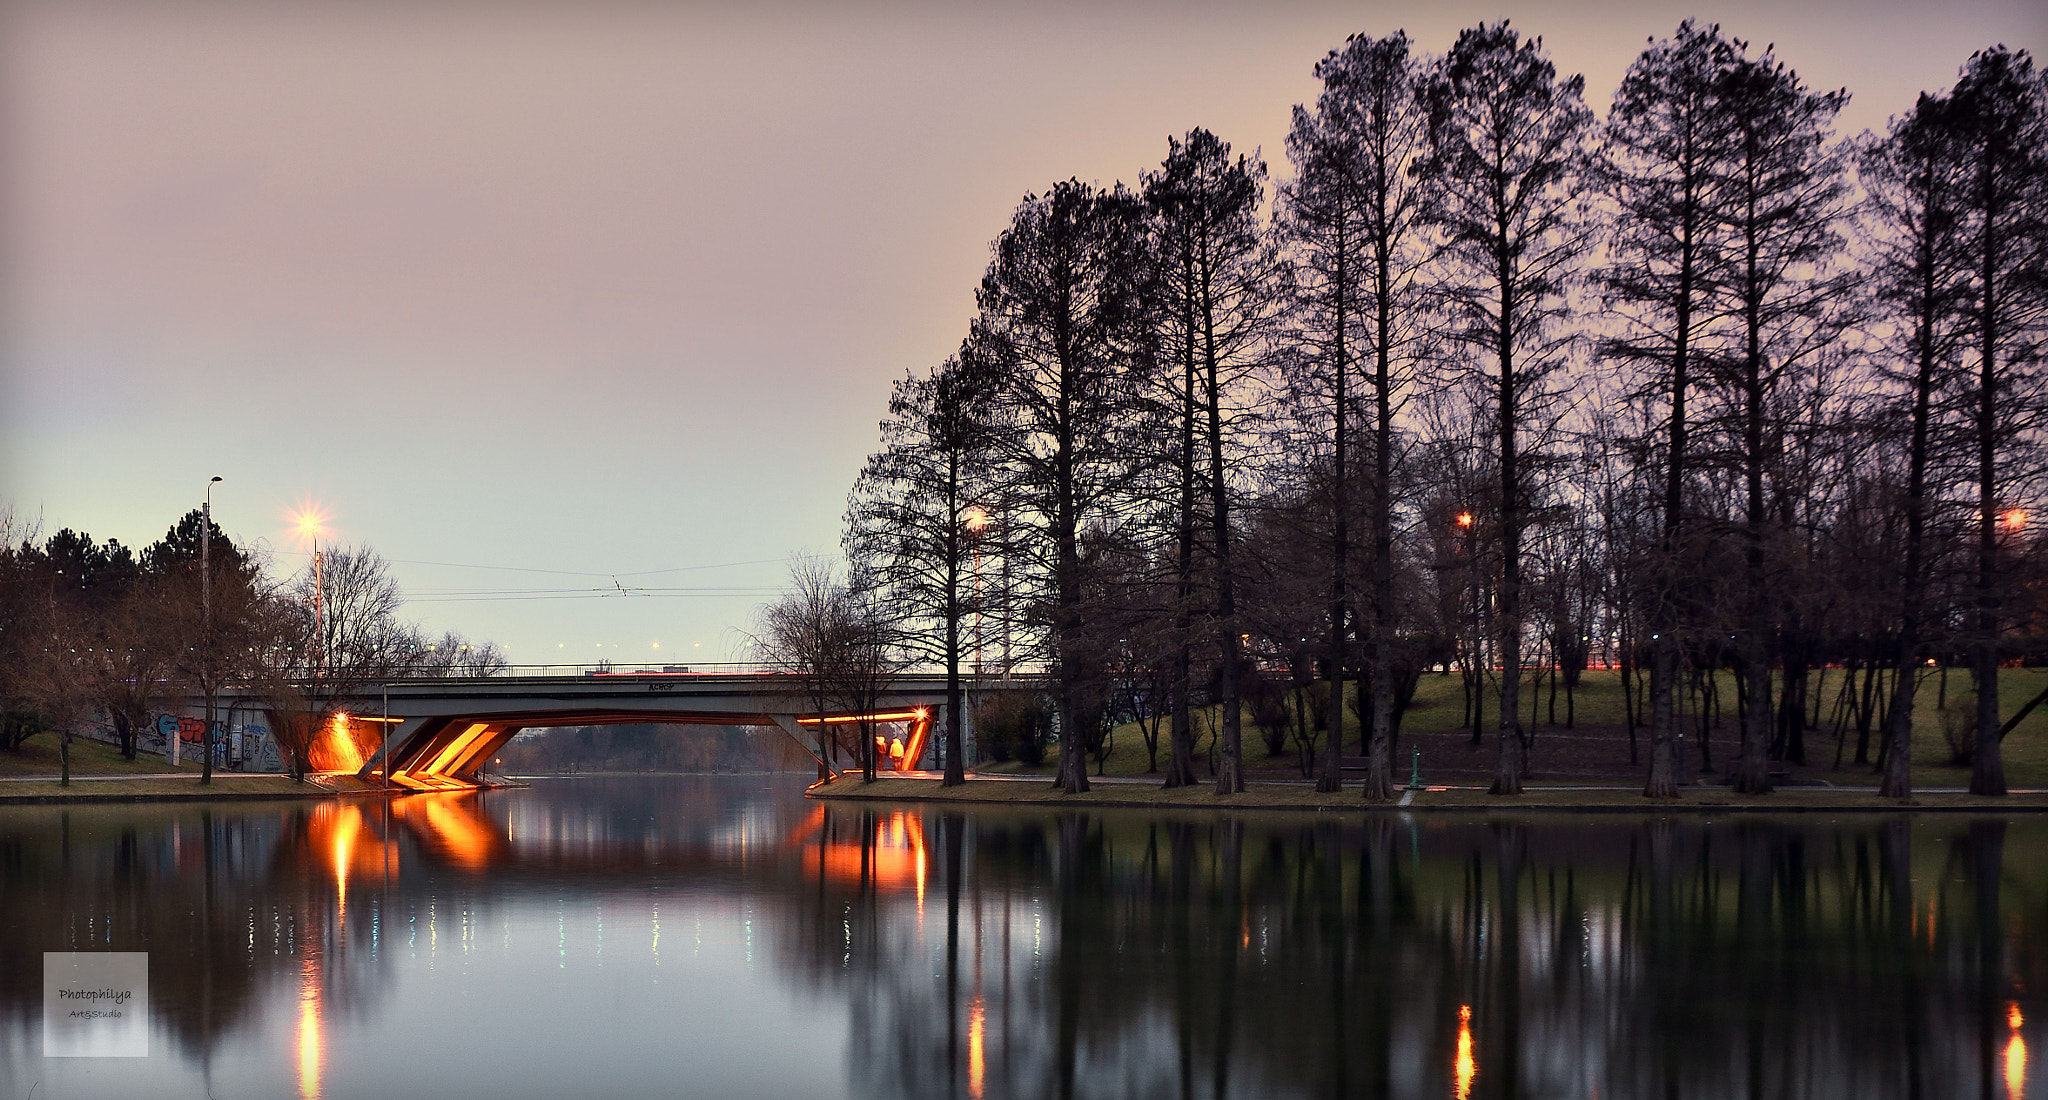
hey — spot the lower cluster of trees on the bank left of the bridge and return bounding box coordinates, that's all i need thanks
[0,510,506,782]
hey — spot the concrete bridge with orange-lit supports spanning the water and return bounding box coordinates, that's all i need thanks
[323,672,1016,791]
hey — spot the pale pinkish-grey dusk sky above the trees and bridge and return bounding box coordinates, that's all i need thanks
[0,0,2048,666]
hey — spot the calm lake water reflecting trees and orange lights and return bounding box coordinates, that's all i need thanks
[0,778,2048,1100]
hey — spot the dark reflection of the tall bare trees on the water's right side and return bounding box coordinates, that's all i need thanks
[784,805,2048,1098]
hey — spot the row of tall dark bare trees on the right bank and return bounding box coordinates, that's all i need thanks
[786,20,2048,801]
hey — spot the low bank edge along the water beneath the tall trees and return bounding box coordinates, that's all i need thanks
[805,778,2048,815]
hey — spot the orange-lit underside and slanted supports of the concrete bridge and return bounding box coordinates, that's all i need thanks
[358,707,932,791]
